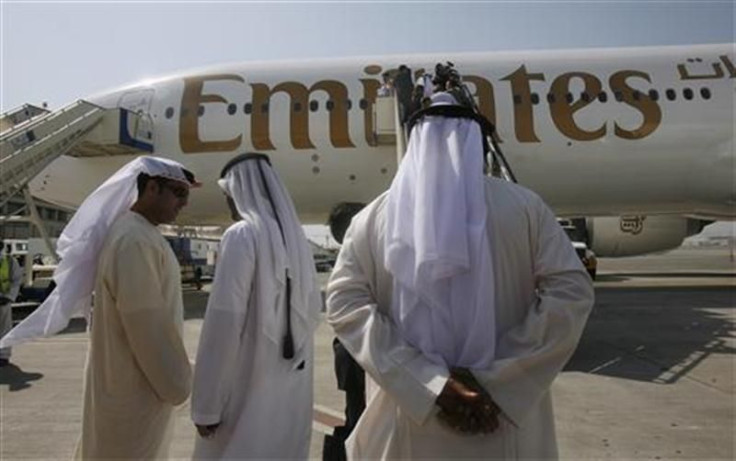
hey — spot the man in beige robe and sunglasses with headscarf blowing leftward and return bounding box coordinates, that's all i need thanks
[0,156,198,460]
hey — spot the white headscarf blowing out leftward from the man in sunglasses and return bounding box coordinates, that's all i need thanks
[0,156,198,347]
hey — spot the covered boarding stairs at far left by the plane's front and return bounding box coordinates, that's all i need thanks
[0,100,153,260]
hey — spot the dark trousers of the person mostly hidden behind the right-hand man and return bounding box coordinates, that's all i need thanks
[322,338,365,461]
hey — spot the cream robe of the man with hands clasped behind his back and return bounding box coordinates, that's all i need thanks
[327,179,593,459]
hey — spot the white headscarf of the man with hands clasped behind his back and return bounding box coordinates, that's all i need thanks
[384,93,496,368]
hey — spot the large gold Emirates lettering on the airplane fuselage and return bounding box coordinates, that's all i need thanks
[179,65,662,154]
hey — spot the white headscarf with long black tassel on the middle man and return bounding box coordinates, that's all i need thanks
[218,154,320,356]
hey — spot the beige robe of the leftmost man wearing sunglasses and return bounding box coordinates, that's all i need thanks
[76,211,191,459]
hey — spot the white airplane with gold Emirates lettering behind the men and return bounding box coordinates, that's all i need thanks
[24,43,736,256]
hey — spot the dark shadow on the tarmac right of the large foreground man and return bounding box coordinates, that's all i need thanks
[565,286,736,386]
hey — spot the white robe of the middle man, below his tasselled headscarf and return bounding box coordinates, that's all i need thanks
[192,218,314,459]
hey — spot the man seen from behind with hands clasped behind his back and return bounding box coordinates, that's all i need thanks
[327,95,593,459]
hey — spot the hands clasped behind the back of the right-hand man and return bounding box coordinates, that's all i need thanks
[437,369,501,434]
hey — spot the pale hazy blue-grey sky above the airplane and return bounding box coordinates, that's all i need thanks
[0,0,736,244]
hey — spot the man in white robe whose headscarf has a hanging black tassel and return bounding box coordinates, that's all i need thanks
[192,154,320,459]
